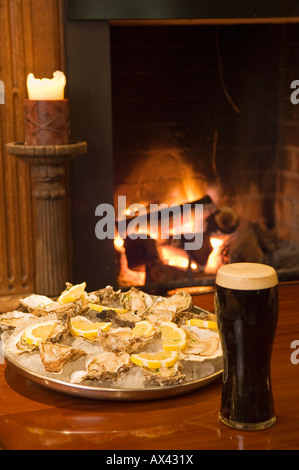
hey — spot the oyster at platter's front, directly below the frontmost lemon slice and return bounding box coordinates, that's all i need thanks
[141,362,185,387]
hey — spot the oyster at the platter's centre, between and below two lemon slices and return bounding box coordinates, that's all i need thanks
[99,327,157,354]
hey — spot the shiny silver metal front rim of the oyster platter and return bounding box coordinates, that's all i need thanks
[0,307,223,401]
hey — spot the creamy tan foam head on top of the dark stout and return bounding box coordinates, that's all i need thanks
[216,263,278,290]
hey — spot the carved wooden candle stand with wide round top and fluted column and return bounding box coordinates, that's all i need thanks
[6,142,87,297]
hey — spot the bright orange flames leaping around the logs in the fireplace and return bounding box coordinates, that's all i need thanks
[114,148,231,286]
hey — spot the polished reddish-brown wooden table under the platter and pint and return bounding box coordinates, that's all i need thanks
[0,283,299,455]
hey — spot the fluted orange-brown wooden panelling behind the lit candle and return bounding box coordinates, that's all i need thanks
[0,0,64,296]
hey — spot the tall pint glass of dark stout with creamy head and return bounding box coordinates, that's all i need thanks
[215,263,278,430]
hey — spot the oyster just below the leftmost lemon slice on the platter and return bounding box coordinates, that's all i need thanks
[39,343,86,374]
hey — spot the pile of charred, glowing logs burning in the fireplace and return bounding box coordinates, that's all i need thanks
[115,196,239,286]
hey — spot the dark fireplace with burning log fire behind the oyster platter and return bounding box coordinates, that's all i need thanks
[67,2,299,292]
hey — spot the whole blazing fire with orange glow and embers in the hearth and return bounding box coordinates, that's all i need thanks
[114,149,234,286]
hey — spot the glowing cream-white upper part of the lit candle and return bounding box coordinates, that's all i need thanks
[27,71,66,101]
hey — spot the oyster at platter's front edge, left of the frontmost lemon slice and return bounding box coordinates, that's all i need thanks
[70,352,131,383]
